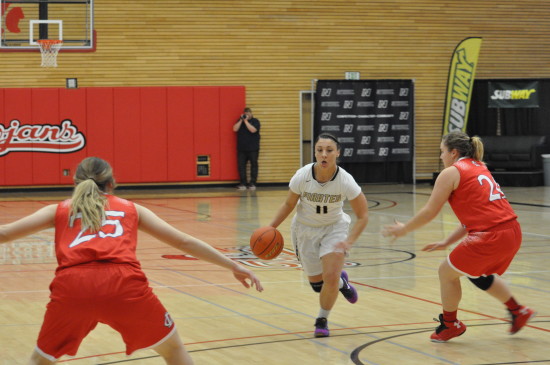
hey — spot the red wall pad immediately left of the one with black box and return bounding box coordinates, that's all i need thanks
[166,87,196,182]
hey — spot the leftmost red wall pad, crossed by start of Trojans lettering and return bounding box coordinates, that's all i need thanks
[2,88,33,185]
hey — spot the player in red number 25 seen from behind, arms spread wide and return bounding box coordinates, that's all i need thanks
[0,157,263,365]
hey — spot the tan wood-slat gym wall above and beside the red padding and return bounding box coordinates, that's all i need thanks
[0,0,550,183]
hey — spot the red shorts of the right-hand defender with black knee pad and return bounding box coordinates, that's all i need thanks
[447,220,521,278]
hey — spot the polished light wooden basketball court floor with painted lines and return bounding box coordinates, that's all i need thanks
[0,184,550,365]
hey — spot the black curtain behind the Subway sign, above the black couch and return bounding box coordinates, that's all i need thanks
[467,79,550,136]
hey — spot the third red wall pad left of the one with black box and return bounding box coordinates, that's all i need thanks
[113,87,142,183]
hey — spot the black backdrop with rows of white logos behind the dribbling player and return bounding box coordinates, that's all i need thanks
[314,80,414,183]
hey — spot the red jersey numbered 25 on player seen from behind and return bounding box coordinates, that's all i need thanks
[55,195,140,270]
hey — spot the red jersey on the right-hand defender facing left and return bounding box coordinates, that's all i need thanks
[449,158,517,232]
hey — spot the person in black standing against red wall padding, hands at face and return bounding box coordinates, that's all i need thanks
[233,108,260,190]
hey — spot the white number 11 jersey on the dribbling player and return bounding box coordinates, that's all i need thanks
[289,163,361,227]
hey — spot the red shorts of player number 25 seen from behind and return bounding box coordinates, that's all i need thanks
[37,263,175,361]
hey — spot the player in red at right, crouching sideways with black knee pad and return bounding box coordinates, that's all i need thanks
[383,131,535,342]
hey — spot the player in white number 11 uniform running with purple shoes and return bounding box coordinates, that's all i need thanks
[270,133,368,337]
